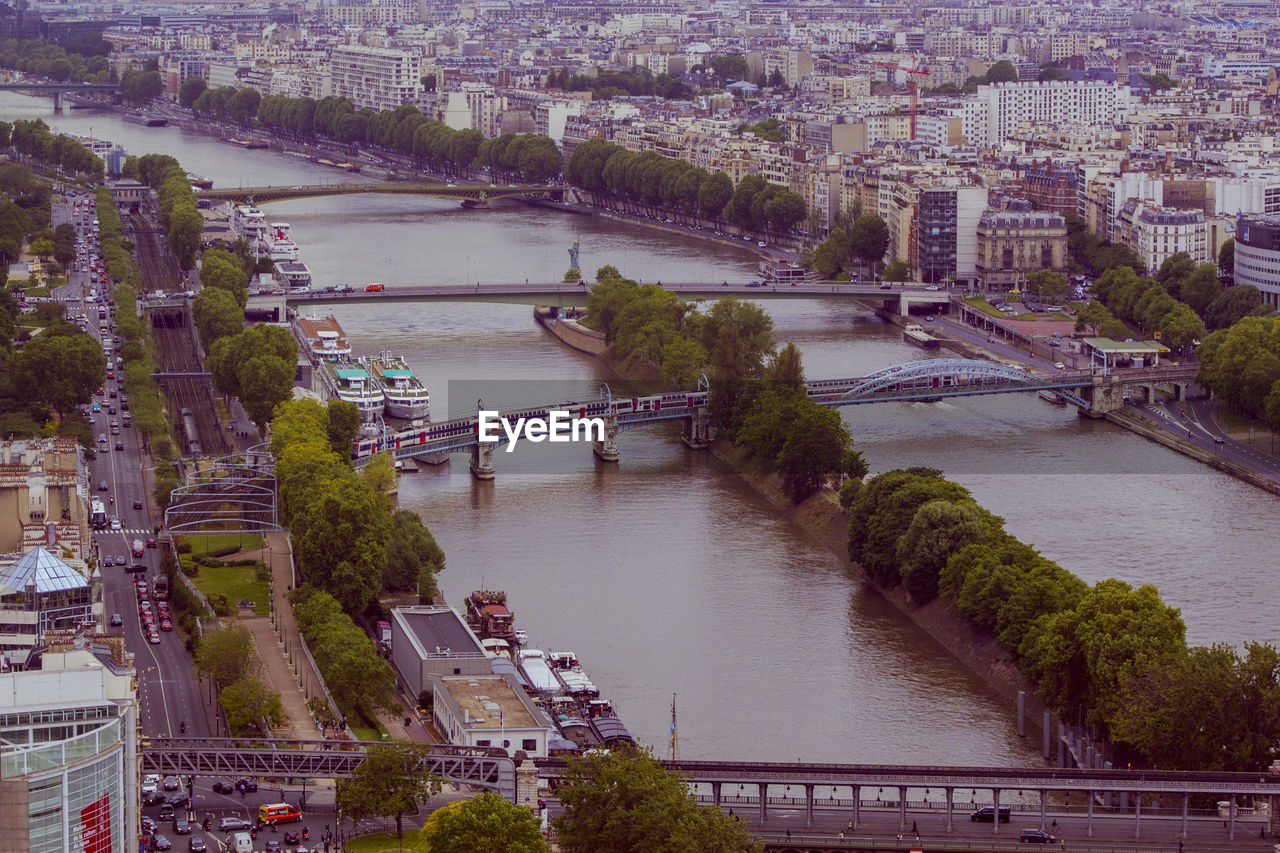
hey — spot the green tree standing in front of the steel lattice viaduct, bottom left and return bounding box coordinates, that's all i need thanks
[337,740,442,841]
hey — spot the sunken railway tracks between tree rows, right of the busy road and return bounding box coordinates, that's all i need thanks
[124,204,230,455]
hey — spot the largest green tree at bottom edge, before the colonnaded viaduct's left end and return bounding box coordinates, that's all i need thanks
[554,747,763,853]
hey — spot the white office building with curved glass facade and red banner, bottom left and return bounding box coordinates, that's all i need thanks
[0,638,138,853]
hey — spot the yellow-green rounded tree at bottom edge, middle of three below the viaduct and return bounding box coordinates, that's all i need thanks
[421,792,548,853]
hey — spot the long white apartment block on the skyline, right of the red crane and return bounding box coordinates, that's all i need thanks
[964,81,1129,146]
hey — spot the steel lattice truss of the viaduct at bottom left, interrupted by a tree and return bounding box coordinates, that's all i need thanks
[142,738,516,802]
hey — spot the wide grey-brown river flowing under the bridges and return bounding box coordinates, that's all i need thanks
[12,92,1280,765]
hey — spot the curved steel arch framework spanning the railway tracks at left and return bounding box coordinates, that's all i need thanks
[164,444,282,535]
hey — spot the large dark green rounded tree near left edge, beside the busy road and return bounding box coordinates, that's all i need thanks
[13,333,106,420]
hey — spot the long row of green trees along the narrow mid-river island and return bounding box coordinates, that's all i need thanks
[550,268,1280,771]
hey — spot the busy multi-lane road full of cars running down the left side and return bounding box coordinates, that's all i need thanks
[52,190,216,736]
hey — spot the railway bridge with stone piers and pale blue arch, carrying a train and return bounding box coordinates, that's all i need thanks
[352,359,1196,479]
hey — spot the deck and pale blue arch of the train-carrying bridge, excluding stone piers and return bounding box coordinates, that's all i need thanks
[352,359,1196,464]
